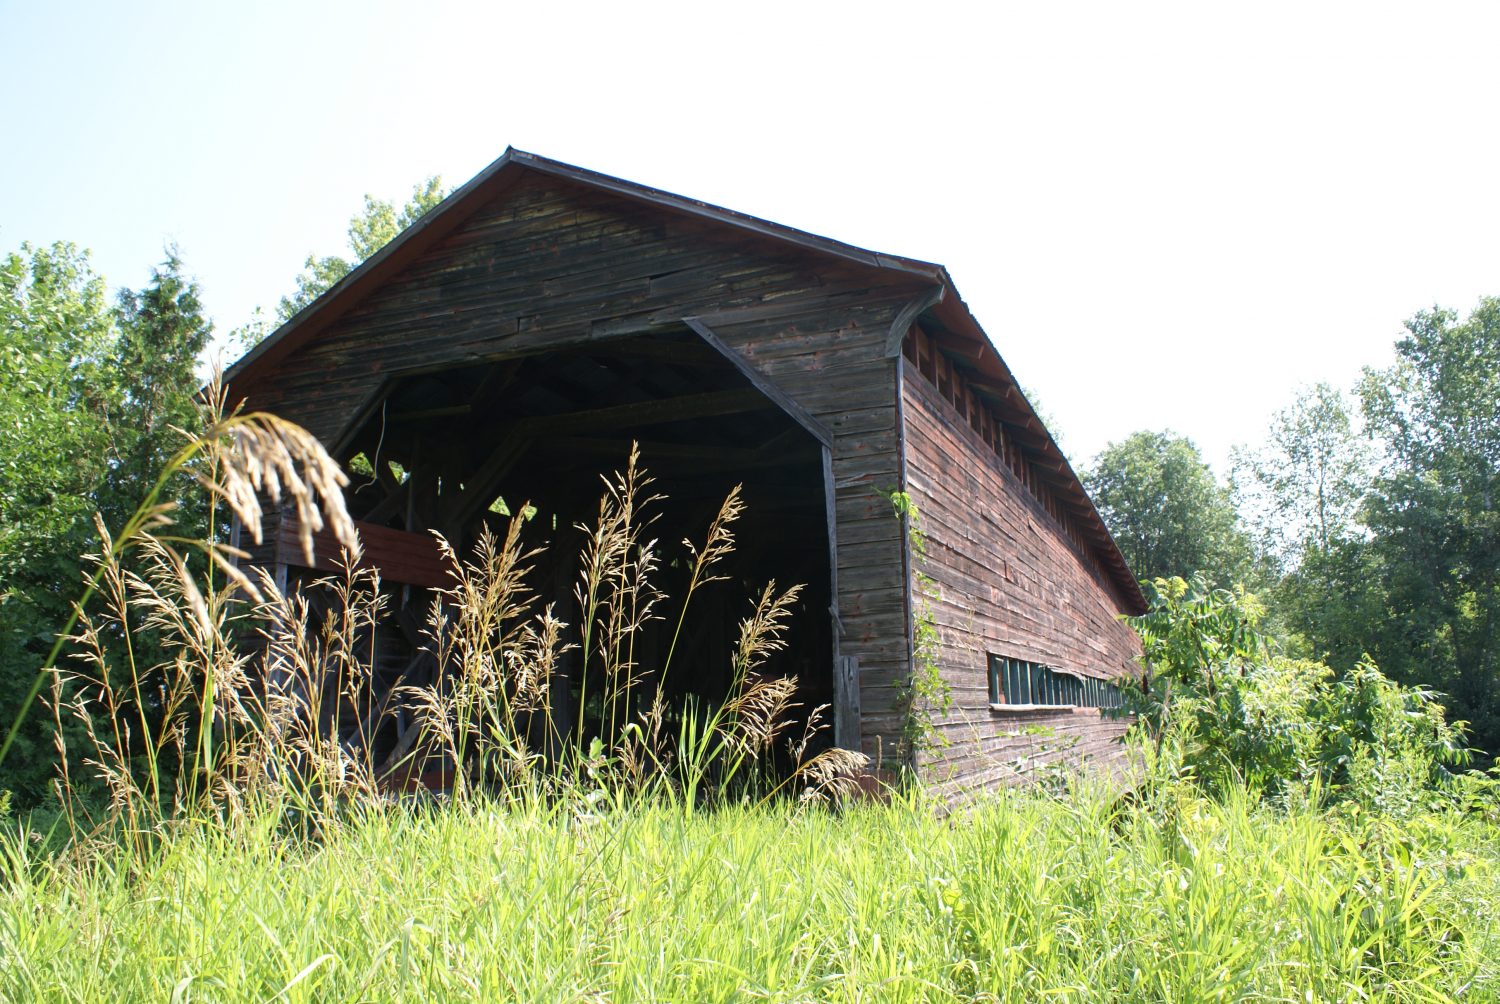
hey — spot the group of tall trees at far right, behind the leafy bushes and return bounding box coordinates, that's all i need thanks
[1235,299,1500,753]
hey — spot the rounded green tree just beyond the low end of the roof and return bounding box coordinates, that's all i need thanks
[1083,432,1251,584]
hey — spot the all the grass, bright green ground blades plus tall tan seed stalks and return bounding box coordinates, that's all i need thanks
[0,387,1500,1001]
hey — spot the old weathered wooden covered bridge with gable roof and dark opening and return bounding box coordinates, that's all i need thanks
[228,150,1143,788]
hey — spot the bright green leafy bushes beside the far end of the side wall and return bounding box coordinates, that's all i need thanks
[1127,576,1469,813]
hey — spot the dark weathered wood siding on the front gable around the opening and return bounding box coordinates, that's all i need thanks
[240,174,918,752]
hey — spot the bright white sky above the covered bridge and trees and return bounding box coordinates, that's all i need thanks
[0,0,1500,473]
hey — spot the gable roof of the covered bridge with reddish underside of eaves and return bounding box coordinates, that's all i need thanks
[225,147,1146,612]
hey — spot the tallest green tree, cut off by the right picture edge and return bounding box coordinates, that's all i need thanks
[1361,297,1500,753]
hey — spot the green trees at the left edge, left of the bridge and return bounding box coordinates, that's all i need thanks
[0,243,212,804]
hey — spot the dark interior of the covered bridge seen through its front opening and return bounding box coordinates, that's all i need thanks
[278,329,833,768]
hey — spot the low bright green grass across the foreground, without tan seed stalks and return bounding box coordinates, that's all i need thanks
[0,785,1500,1001]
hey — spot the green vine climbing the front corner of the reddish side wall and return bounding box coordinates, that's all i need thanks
[887,489,953,765]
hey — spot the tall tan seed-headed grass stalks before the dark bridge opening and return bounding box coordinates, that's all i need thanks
[11,375,864,845]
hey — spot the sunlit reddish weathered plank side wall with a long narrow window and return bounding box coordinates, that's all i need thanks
[902,365,1140,794]
